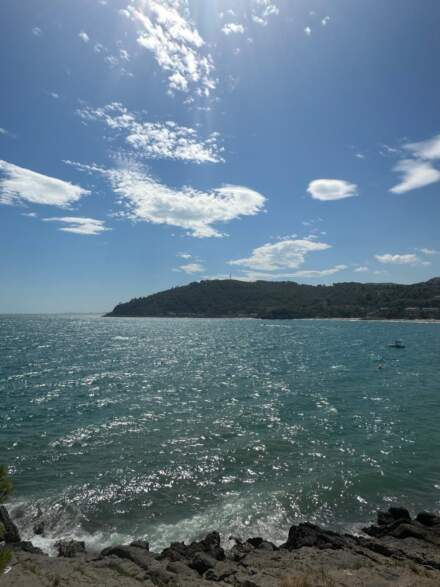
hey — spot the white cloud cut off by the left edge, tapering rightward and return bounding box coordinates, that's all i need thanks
[0,159,90,208]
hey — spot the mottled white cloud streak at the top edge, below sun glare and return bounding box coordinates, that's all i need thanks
[127,0,216,96]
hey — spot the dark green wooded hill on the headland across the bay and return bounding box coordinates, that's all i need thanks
[106,277,440,319]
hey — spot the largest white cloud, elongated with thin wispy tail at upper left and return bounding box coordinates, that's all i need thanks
[67,162,266,238]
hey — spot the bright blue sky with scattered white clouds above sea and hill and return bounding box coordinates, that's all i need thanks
[0,0,440,313]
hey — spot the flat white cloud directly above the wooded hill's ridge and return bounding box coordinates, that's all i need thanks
[229,239,331,271]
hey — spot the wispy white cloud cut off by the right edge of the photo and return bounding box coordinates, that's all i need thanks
[390,135,440,194]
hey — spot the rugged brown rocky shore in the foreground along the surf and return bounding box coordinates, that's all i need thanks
[0,506,440,587]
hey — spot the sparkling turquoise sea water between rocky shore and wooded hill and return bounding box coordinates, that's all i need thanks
[0,316,440,548]
